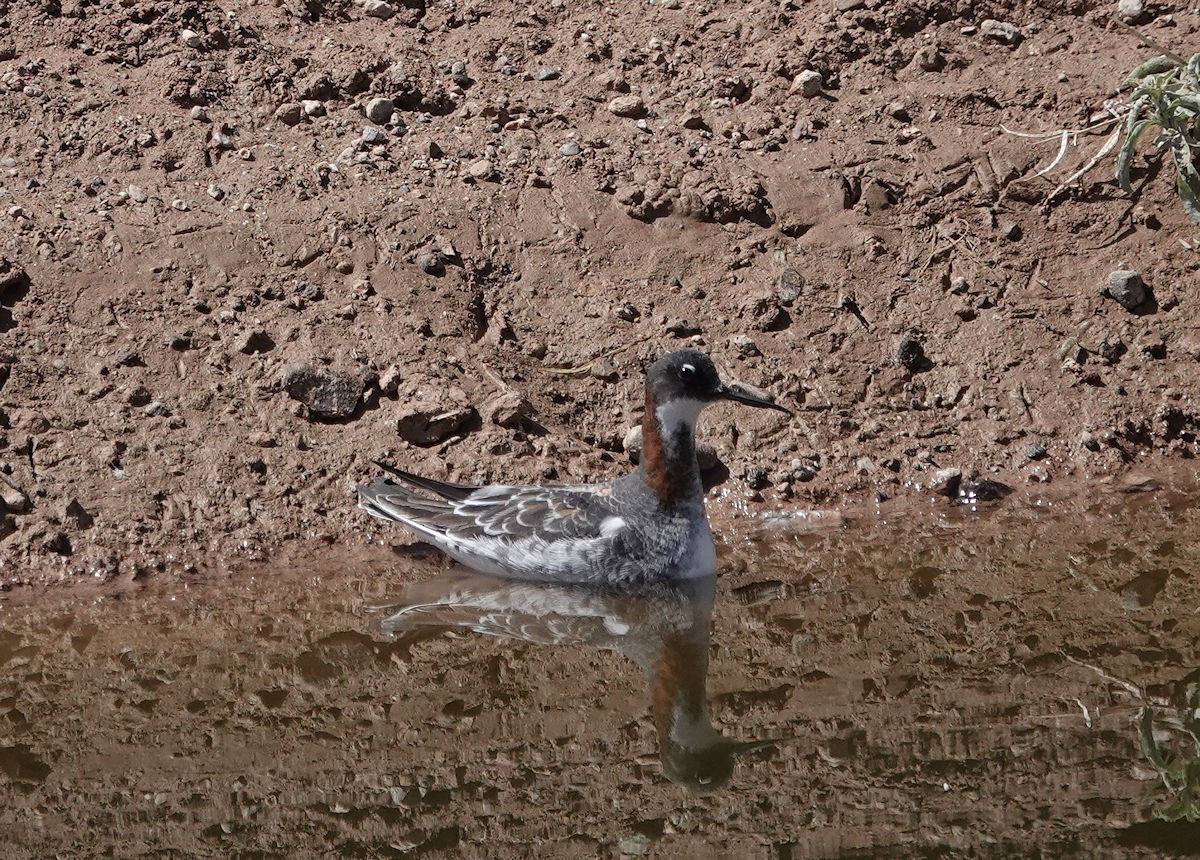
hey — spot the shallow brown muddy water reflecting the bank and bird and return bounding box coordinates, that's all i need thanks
[0,493,1200,858]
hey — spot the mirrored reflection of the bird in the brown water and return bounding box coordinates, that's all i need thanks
[377,570,774,793]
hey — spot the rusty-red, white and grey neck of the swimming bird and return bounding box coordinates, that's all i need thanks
[641,391,703,506]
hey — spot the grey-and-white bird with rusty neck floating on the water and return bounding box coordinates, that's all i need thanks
[358,349,791,584]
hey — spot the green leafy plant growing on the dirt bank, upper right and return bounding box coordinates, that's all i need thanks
[1117,54,1200,223]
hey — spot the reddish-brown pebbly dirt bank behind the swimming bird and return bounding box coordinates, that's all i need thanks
[0,0,1200,588]
